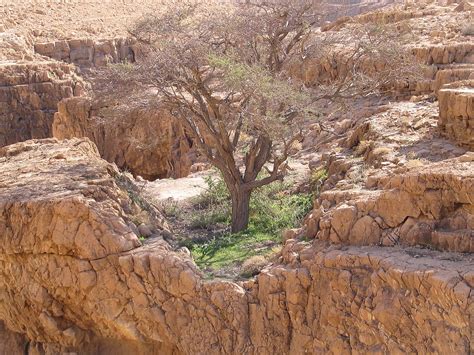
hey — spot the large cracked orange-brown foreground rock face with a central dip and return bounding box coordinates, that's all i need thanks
[0,139,474,354]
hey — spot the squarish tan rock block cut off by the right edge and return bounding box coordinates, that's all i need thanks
[438,80,474,150]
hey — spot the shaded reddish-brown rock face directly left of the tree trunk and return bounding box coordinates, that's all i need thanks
[53,97,197,180]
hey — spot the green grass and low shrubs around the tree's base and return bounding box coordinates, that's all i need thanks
[181,178,312,273]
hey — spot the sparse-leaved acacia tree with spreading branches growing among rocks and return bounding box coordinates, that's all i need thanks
[99,0,418,232]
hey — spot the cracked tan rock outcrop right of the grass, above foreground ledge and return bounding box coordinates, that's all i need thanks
[305,155,474,253]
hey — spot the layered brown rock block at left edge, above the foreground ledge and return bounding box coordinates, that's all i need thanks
[0,62,82,147]
